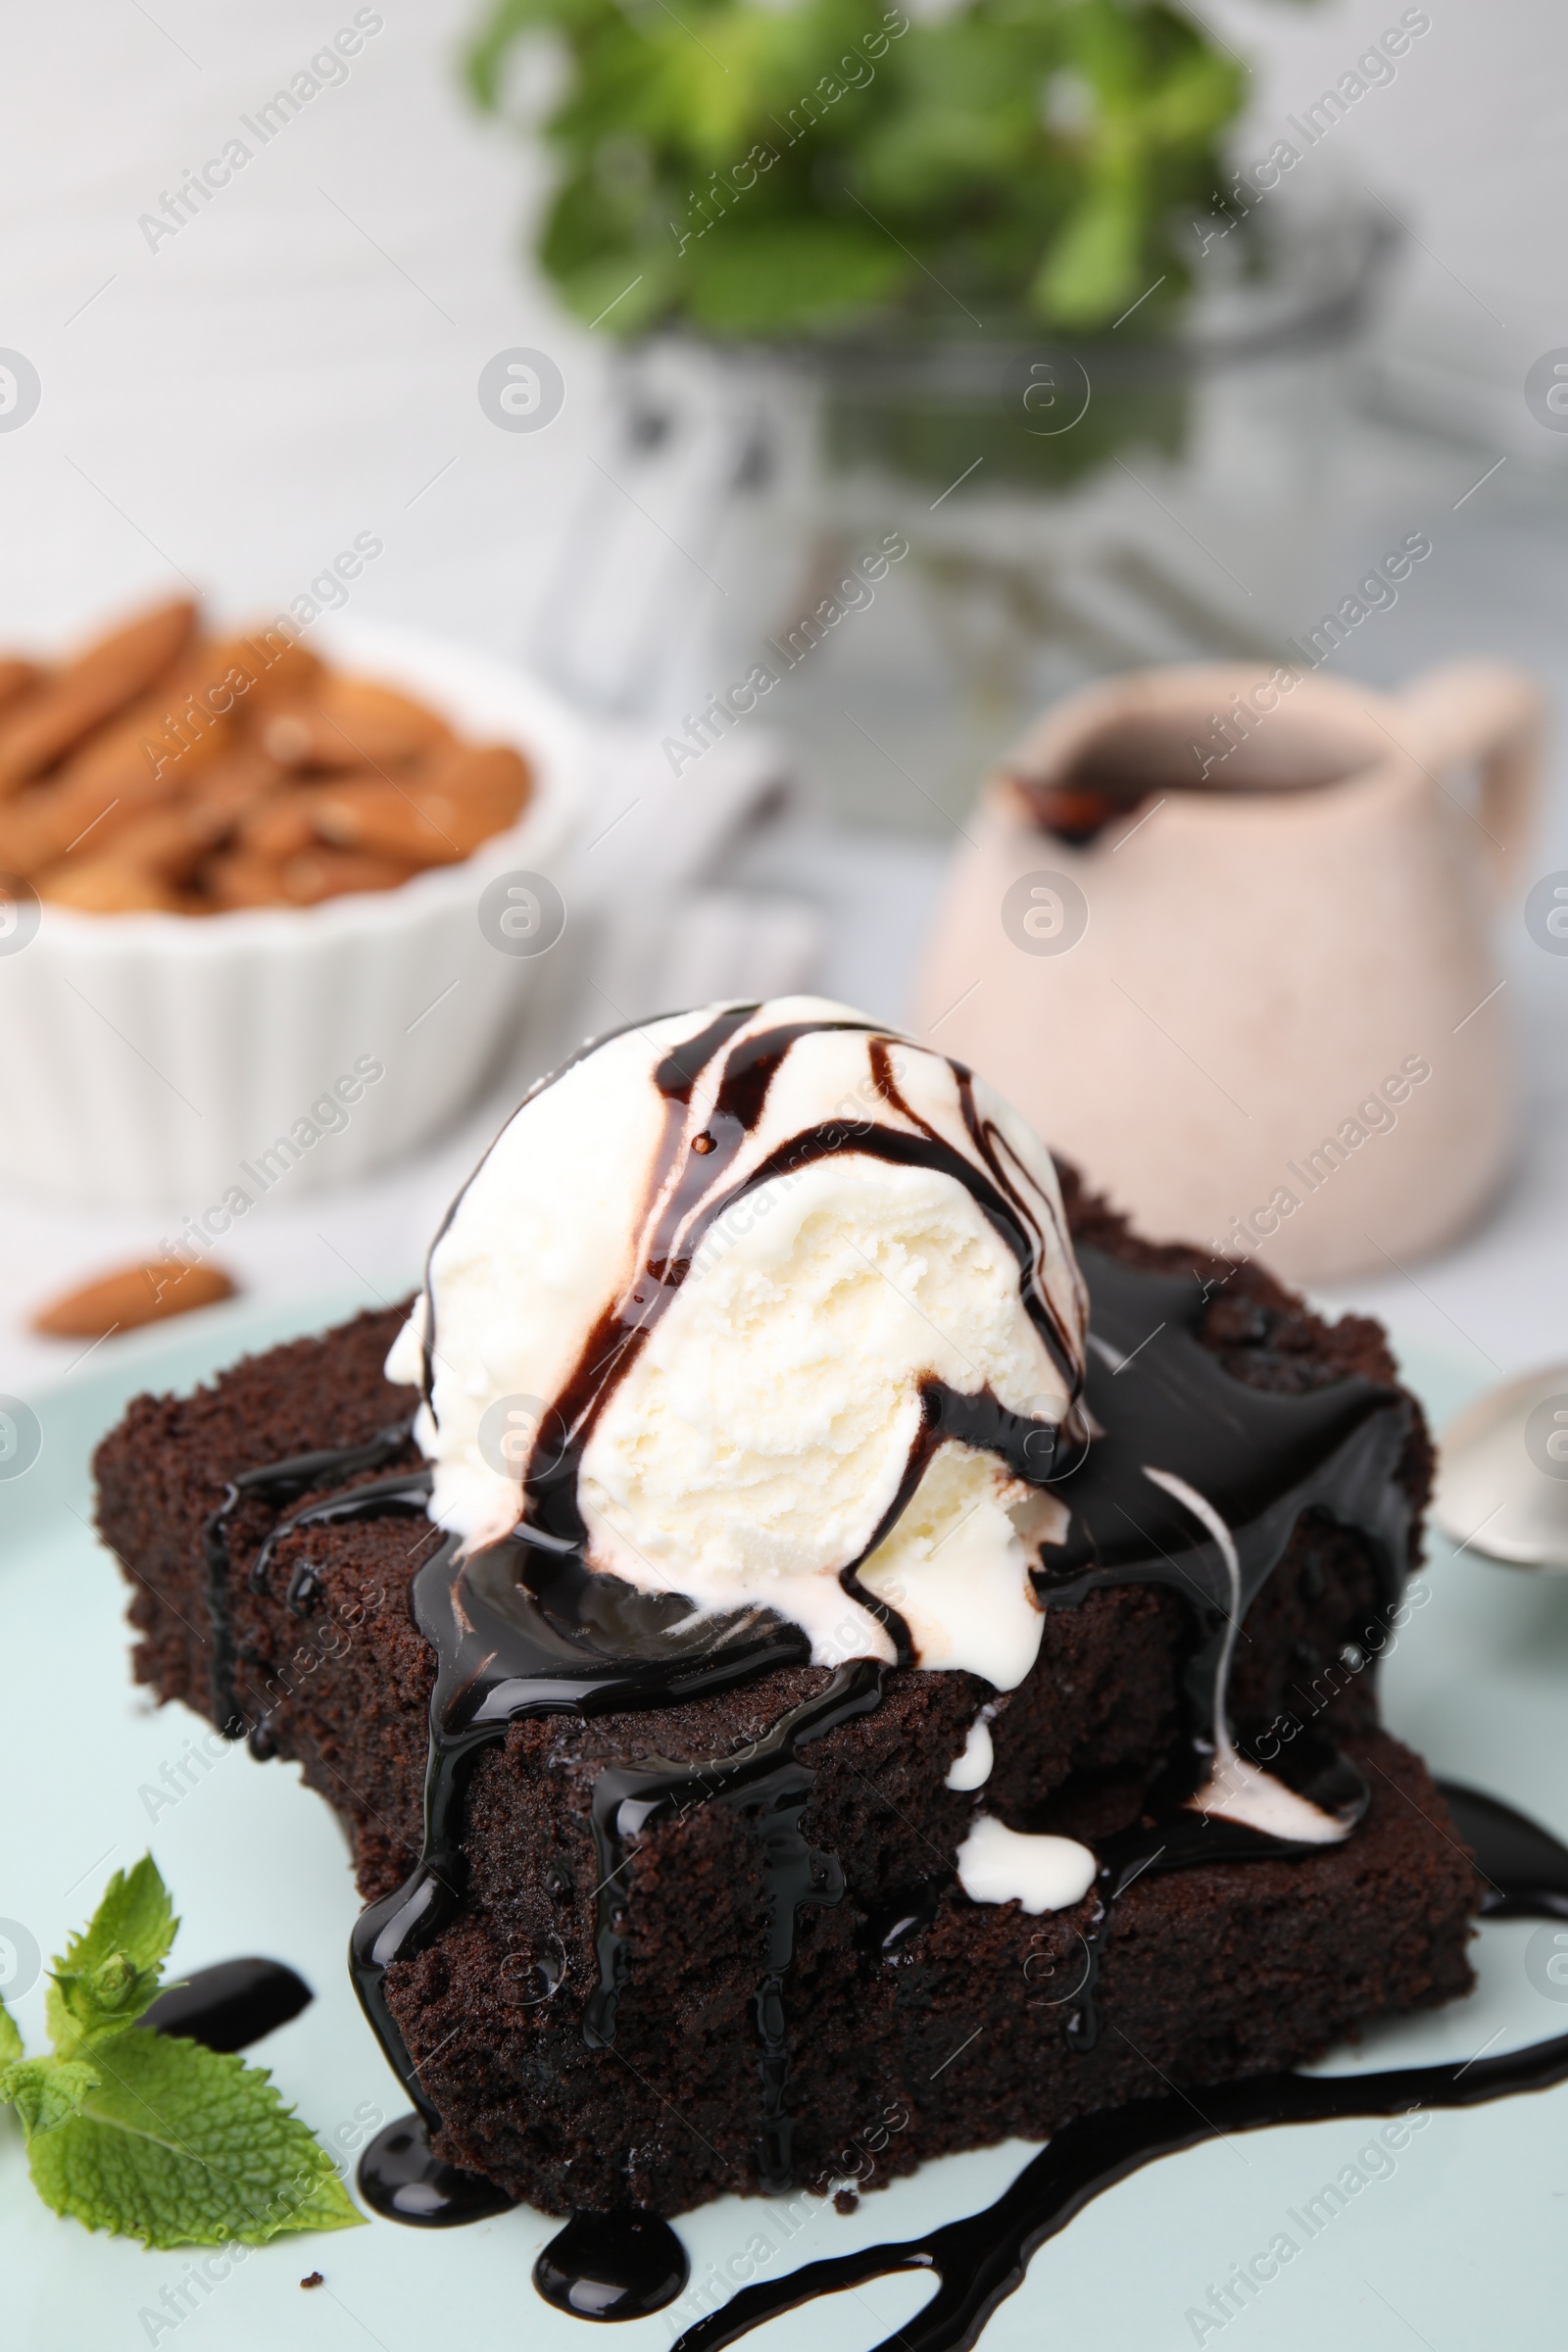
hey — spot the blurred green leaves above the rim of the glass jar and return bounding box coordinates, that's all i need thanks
[467,0,1244,339]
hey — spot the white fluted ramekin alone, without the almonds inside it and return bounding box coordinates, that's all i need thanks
[0,621,590,1230]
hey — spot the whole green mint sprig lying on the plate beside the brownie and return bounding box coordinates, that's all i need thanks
[0,1853,365,2246]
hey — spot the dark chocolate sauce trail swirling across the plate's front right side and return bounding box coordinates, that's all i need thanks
[672,1783,1568,2352]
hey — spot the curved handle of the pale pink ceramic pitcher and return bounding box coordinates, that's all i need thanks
[1396,661,1546,899]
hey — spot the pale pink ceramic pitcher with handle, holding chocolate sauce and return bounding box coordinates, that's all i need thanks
[914,663,1544,1282]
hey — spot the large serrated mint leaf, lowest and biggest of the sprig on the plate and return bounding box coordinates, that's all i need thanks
[23,2033,365,2246]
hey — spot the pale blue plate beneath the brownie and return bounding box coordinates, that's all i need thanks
[0,1298,1568,2352]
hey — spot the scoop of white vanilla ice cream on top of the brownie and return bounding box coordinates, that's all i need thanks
[388,998,1084,1689]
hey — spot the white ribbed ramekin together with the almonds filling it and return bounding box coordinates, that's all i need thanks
[0,602,590,1240]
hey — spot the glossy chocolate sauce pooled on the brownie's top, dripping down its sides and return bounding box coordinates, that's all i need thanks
[236,1242,1410,2223]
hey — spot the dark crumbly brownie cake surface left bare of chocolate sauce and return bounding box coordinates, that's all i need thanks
[96,1171,1476,2213]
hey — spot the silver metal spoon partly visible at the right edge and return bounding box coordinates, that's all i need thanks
[1432,1364,1568,1574]
